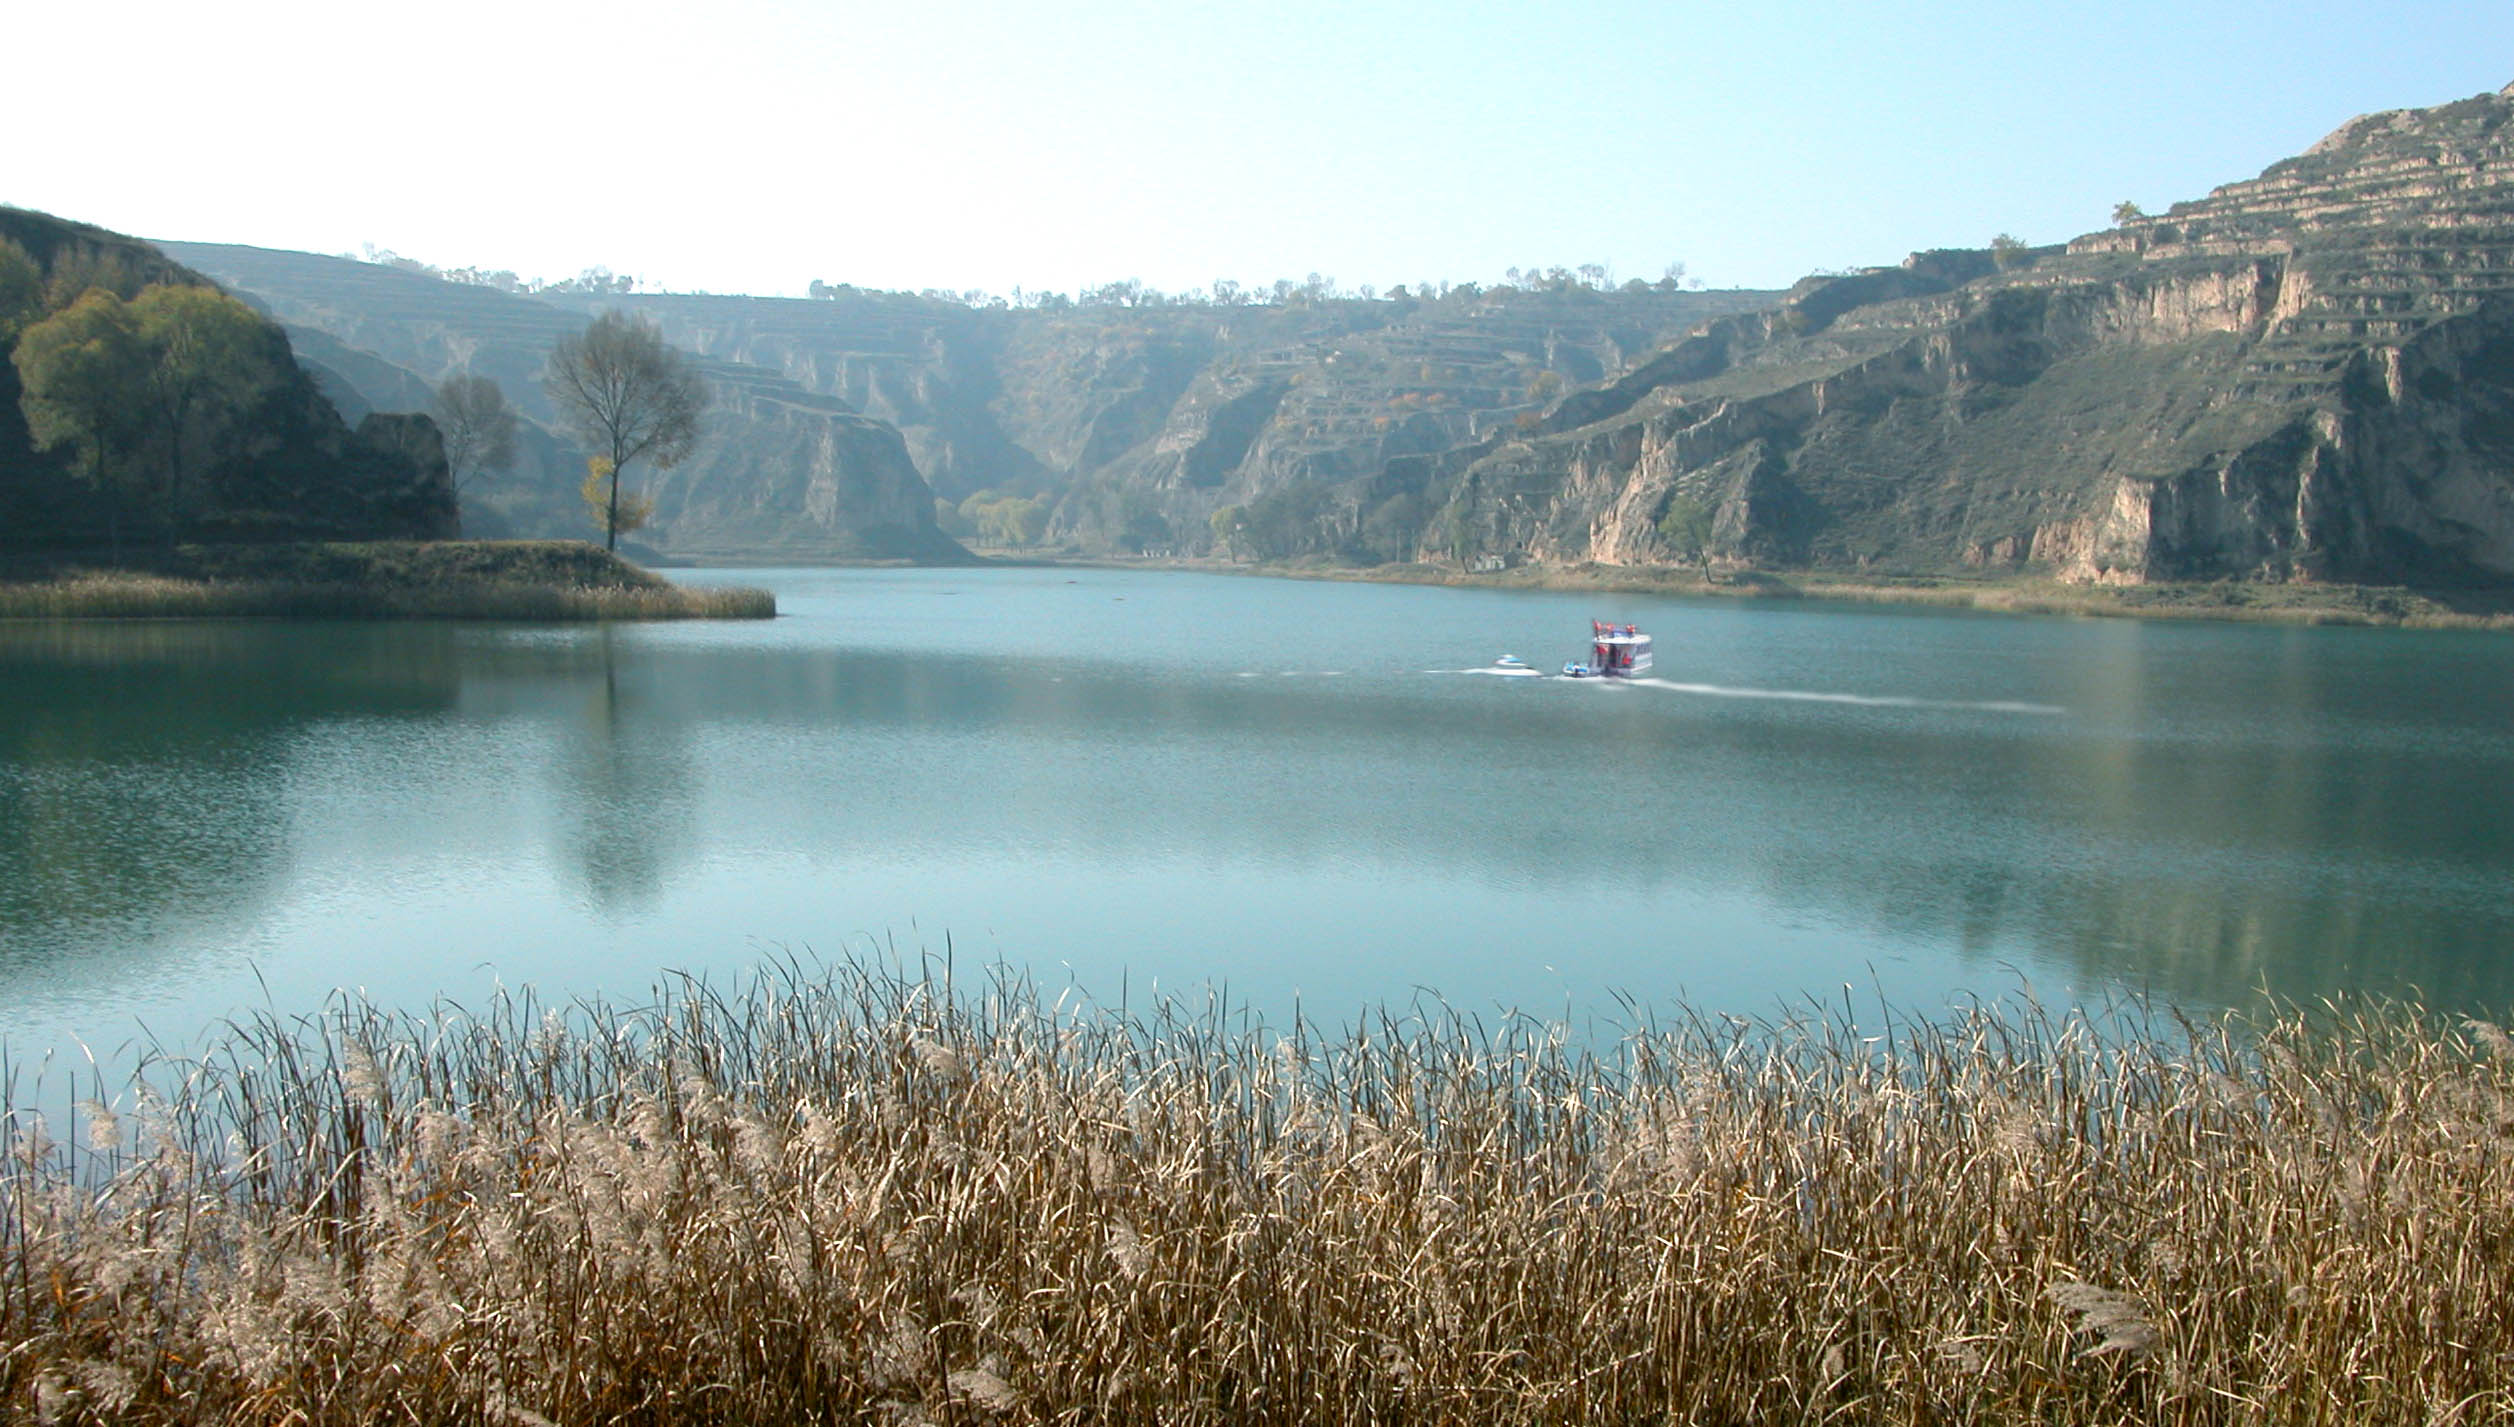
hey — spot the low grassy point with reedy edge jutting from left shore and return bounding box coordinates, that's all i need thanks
[0,540,777,621]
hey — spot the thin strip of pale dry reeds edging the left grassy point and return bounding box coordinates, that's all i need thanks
[0,573,777,621]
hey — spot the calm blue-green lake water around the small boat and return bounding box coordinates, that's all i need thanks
[0,570,2514,1063]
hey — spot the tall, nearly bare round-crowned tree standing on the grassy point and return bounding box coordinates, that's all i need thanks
[543,312,706,550]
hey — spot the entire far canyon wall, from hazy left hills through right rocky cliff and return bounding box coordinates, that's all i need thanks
[168,85,2514,585]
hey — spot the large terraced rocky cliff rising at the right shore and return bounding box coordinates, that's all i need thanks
[1438,88,2514,583]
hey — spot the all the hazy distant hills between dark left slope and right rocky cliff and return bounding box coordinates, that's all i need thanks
[168,244,1777,555]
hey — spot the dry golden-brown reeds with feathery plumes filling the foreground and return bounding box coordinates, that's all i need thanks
[0,965,2514,1427]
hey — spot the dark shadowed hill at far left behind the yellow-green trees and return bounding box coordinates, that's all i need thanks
[0,209,455,550]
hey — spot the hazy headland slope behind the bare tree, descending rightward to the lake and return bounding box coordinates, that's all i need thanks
[166,244,968,560]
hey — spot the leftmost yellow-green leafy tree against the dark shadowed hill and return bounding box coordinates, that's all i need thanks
[10,289,148,563]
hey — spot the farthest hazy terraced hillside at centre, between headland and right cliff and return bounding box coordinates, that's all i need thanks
[555,286,1777,550]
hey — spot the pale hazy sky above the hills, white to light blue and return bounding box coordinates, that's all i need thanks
[0,0,2514,294]
